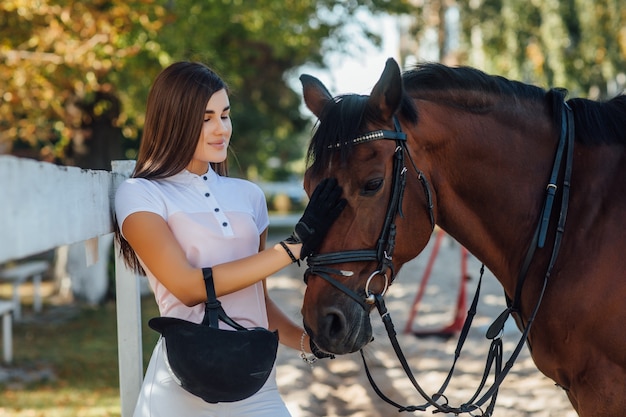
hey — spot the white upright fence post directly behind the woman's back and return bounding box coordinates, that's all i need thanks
[111,161,143,417]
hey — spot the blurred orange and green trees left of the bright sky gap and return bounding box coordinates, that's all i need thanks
[0,0,420,177]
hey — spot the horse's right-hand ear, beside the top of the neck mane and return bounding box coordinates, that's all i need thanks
[367,58,403,120]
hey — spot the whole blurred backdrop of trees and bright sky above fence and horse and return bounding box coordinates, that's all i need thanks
[0,0,626,177]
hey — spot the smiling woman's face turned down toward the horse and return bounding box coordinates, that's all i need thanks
[187,89,233,175]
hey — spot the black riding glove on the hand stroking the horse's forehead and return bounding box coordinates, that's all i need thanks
[285,178,347,259]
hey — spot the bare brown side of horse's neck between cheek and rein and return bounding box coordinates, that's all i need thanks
[422,106,556,288]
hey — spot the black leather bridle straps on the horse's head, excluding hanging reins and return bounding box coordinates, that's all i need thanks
[304,116,435,312]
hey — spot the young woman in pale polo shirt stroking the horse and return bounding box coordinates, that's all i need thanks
[115,62,345,417]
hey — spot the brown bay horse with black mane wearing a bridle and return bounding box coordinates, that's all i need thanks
[300,59,626,417]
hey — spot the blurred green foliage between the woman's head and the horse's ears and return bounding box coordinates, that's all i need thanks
[132,0,416,180]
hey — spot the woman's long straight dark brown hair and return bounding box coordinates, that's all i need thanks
[114,62,228,274]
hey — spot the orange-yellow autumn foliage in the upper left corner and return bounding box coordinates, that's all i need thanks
[0,0,163,161]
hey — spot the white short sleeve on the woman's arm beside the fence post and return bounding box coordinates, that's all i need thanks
[115,178,166,230]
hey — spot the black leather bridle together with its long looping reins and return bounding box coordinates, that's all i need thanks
[305,96,574,416]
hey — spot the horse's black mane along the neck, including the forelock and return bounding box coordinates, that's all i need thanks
[307,63,626,173]
